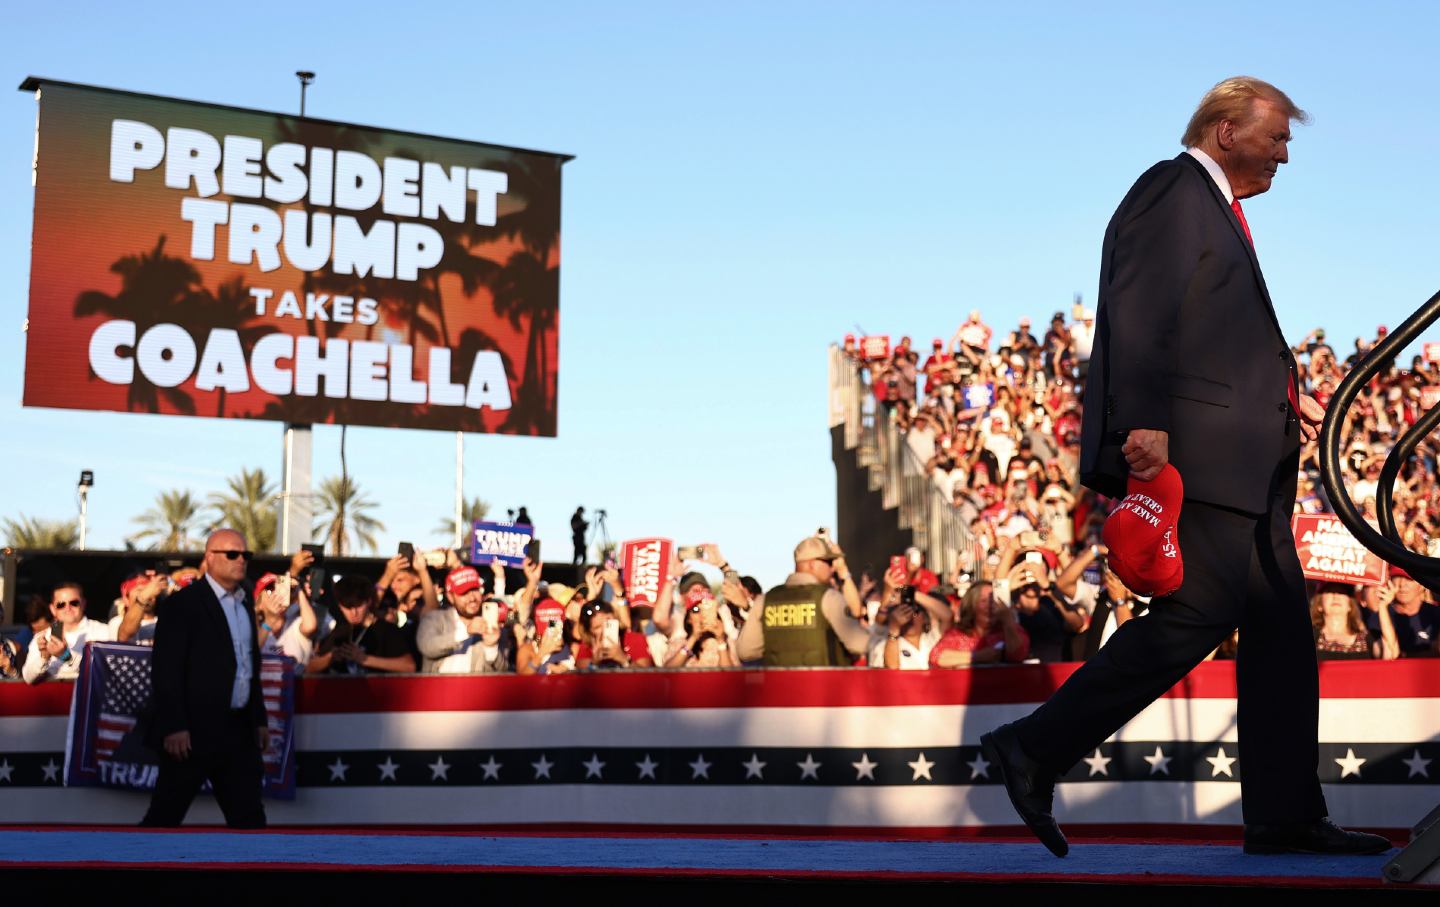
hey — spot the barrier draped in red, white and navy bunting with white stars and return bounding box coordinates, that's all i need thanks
[0,659,1440,829]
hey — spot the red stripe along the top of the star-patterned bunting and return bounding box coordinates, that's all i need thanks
[0,659,1440,717]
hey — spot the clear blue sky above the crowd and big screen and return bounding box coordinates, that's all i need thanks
[0,1,1440,583]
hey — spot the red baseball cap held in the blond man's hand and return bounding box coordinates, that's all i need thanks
[1102,464,1185,596]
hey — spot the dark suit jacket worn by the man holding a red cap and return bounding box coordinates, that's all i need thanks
[1080,154,1299,514]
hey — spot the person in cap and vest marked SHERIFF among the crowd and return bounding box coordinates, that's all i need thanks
[736,536,870,667]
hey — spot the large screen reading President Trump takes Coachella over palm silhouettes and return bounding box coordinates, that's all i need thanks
[22,79,569,436]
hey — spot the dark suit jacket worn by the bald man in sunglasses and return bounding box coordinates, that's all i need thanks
[148,577,265,752]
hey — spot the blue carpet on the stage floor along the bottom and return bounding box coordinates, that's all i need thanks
[0,828,1416,888]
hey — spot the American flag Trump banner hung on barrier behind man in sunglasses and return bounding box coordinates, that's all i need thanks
[65,642,295,800]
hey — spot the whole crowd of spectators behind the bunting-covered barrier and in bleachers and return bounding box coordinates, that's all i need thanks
[0,312,1440,682]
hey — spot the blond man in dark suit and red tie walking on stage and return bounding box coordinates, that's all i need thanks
[981,78,1390,857]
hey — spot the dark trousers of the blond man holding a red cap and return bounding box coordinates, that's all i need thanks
[1015,455,1326,823]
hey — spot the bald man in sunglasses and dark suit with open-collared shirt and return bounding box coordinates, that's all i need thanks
[141,530,266,828]
